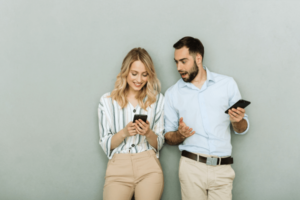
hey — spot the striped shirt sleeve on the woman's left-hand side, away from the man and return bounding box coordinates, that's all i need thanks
[98,97,113,159]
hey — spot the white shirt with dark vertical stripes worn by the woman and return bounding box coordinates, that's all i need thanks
[98,93,165,159]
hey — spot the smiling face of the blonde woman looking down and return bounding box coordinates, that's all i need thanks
[127,60,148,91]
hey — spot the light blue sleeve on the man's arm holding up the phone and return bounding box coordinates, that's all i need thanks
[228,78,250,135]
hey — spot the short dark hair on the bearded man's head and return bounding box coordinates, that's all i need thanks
[173,36,204,60]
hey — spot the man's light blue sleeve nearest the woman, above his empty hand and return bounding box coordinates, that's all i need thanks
[164,90,179,134]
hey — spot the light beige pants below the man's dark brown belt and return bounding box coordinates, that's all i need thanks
[179,154,235,200]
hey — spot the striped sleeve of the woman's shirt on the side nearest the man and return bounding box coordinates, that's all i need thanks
[149,94,165,156]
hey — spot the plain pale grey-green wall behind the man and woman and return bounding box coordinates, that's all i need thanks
[0,0,300,200]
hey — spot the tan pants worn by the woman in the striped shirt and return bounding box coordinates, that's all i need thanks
[103,150,164,200]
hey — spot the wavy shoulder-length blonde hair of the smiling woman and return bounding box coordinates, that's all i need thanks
[110,47,160,110]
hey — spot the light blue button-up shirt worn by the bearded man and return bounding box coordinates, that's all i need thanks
[164,67,249,156]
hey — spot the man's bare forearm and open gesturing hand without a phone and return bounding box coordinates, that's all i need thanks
[165,117,195,145]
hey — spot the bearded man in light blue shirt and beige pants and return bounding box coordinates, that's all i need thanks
[164,37,249,200]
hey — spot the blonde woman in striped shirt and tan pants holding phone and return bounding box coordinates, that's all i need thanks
[98,48,164,200]
